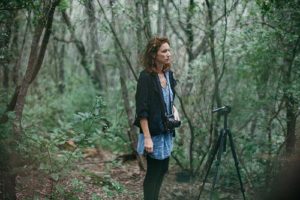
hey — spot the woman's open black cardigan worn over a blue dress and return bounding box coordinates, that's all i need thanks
[134,70,176,136]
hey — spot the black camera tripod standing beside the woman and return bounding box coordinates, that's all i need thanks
[198,106,246,200]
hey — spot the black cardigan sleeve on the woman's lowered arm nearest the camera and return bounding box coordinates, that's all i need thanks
[135,72,149,120]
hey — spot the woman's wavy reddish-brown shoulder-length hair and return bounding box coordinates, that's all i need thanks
[142,37,171,72]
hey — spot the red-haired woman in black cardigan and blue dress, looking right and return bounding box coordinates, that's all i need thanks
[135,37,180,200]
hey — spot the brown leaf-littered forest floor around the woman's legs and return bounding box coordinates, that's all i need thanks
[17,149,241,200]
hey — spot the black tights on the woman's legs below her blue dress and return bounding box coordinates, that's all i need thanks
[144,155,169,200]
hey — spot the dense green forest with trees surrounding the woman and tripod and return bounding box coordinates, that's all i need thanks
[0,0,300,199]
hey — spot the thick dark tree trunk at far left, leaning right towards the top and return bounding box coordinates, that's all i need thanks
[0,1,59,199]
